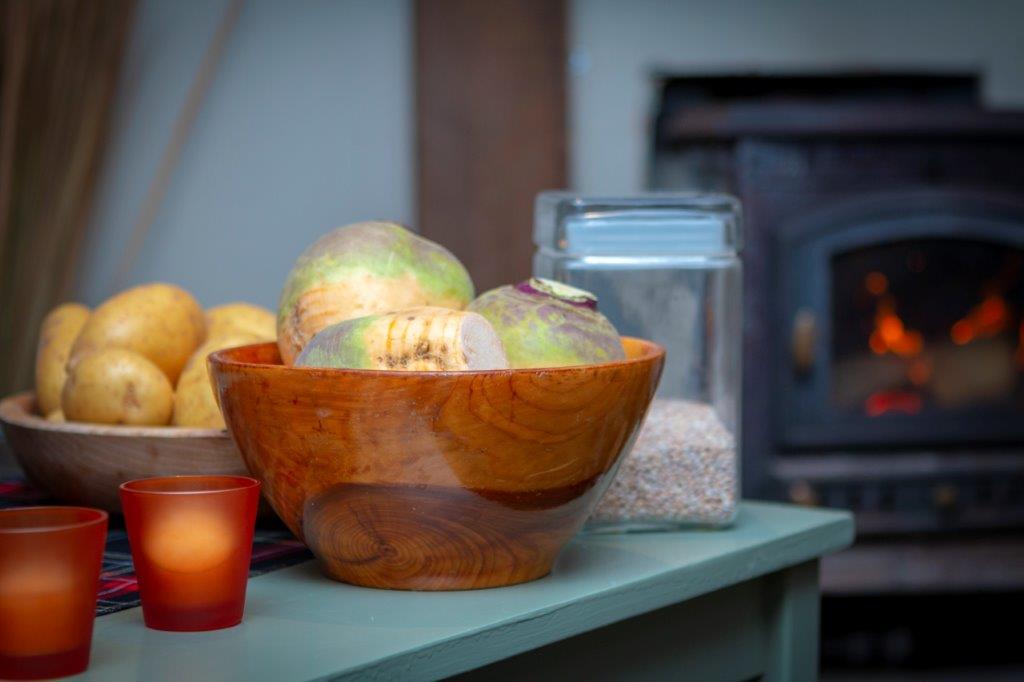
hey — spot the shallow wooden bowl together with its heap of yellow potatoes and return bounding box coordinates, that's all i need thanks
[0,284,276,512]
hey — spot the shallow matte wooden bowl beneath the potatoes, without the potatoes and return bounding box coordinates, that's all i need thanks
[0,393,249,512]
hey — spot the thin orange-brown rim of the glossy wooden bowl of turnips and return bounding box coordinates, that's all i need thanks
[207,336,665,379]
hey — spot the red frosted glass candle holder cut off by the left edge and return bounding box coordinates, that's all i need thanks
[0,507,106,680]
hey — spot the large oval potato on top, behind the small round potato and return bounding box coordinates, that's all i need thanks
[68,283,206,382]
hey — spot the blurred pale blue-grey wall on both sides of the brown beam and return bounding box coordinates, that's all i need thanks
[72,0,1024,306]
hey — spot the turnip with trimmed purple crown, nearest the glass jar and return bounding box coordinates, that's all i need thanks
[468,278,626,368]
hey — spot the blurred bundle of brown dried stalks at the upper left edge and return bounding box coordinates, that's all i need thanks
[0,0,136,395]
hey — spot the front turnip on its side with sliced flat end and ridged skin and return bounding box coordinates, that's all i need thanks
[295,306,509,372]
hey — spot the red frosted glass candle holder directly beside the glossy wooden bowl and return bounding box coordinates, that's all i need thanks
[121,476,259,631]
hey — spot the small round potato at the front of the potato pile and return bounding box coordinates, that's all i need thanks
[60,348,174,426]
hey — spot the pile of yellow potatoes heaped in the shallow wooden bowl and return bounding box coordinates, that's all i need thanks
[36,283,276,428]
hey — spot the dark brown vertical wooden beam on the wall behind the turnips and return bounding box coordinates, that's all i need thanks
[415,0,567,292]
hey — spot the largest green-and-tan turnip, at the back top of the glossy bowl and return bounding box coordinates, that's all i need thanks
[278,221,473,365]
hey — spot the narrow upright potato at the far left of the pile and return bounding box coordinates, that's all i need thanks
[36,303,89,415]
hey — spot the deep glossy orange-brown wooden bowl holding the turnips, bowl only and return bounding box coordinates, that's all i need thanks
[209,339,665,590]
